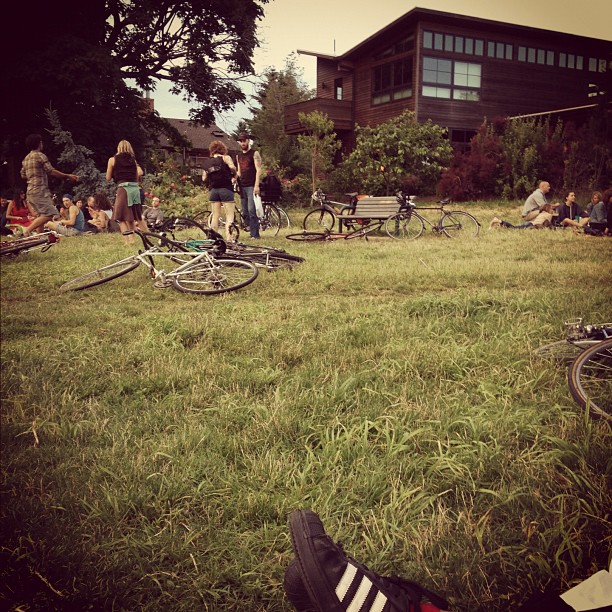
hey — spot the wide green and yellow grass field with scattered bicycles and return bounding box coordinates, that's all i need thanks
[0,204,612,611]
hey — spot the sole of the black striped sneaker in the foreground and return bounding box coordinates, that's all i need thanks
[289,510,345,612]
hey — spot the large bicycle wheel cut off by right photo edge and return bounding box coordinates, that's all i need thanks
[567,338,612,421]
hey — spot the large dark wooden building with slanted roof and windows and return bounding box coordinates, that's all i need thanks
[285,8,612,151]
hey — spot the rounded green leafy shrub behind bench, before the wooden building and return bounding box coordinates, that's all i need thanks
[344,111,452,195]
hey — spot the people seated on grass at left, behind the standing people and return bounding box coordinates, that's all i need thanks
[1,191,164,236]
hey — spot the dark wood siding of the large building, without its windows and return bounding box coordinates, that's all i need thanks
[286,8,612,149]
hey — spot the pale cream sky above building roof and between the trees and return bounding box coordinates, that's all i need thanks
[151,0,612,133]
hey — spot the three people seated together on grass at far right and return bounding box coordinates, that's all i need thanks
[490,181,612,236]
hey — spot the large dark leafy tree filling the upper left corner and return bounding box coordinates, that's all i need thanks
[0,0,268,186]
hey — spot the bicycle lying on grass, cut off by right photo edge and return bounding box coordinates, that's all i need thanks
[534,319,612,421]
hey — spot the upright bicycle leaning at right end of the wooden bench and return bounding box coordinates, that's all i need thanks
[385,196,480,240]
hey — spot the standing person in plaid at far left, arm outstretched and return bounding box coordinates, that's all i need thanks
[21,134,79,236]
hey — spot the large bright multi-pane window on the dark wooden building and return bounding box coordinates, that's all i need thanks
[423,57,482,101]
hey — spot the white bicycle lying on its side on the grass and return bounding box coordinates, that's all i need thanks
[61,230,258,295]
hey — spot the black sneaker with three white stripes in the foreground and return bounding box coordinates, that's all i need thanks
[285,510,448,612]
